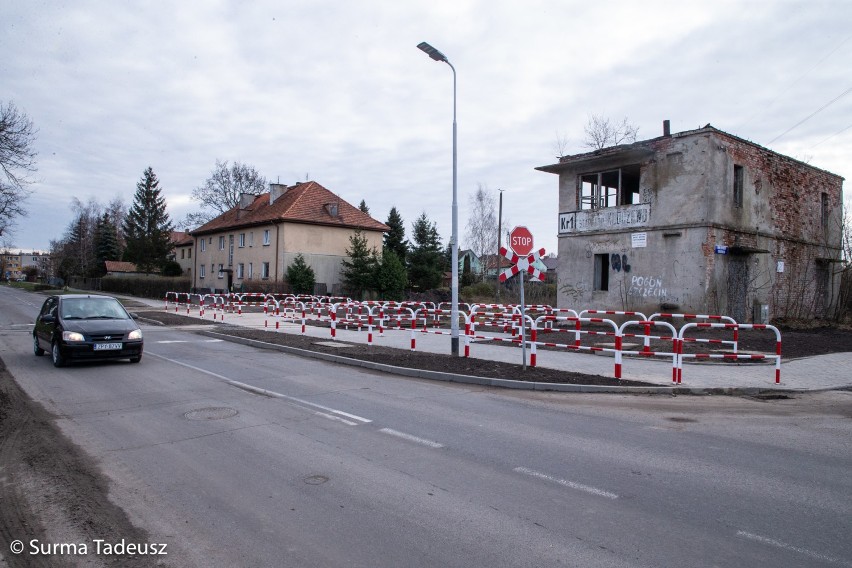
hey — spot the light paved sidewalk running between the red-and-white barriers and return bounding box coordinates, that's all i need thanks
[143,298,852,391]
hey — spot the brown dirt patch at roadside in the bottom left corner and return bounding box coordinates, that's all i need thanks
[0,360,167,567]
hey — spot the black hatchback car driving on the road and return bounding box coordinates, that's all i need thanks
[33,294,142,367]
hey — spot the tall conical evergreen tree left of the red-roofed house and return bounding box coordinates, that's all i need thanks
[123,166,172,272]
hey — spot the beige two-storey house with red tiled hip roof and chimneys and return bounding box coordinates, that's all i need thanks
[189,181,389,293]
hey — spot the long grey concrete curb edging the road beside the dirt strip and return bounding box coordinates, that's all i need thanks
[196,330,824,396]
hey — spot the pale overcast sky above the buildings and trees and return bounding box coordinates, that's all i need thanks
[0,0,852,252]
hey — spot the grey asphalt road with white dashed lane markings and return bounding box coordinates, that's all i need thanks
[0,287,852,567]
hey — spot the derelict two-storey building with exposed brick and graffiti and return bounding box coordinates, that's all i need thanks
[536,121,843,323]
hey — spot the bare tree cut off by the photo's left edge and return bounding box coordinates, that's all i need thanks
[0,102,37,235]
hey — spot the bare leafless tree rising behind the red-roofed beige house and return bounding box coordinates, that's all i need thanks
[180,160,266,228]
